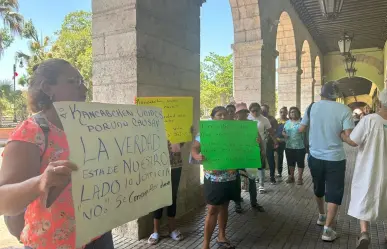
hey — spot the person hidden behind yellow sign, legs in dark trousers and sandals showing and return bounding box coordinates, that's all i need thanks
[148,141,184,245]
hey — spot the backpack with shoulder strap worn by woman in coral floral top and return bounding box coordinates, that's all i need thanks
[4,113,50,241]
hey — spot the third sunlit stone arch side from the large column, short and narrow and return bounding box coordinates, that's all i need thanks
[300,40,314,111]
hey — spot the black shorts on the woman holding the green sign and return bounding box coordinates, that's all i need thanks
[204,178,240,206]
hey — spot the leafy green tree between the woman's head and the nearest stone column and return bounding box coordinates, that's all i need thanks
[52,11,92,100]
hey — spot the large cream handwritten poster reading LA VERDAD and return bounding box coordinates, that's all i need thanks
[54,102,172,248]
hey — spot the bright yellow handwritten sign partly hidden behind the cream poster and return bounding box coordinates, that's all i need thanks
[136,97,193,144]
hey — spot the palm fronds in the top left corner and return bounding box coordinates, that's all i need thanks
[0,0,23,56]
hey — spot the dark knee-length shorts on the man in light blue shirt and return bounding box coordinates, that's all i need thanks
[308,156,346,205]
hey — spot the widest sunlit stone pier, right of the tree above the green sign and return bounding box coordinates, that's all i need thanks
[230,0,262,103]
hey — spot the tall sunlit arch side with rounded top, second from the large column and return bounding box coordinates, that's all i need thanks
[276,11,298,110]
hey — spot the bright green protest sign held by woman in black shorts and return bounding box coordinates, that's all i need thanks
[200,120,261,170]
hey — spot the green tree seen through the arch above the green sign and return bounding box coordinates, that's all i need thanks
[200,53,233,116]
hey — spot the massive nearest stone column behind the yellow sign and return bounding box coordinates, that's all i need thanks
[93,0,204,239]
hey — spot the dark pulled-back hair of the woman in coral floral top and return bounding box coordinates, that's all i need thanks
[28,59,71,113]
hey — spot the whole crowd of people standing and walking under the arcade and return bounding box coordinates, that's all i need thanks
[0,59,387,249]
